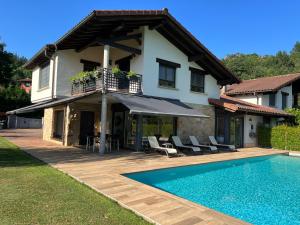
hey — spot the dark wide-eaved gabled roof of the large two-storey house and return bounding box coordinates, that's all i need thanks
[24,9,240,85]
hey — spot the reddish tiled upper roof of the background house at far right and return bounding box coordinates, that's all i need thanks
[226,73,300,95]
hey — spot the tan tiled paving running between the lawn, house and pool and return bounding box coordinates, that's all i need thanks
[0,130,284,225]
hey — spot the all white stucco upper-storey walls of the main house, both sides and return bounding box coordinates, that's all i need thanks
[32,27,220,105]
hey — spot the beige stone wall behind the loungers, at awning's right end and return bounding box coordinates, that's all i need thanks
[177,104,215,142]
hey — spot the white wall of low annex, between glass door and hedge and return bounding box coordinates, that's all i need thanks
[244,115,263,147]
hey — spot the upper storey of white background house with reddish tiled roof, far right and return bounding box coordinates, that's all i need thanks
[225,73,300,109]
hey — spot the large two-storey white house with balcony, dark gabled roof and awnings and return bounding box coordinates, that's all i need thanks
[5,9,290,153]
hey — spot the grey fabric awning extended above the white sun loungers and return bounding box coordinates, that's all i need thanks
[110,93,209,118]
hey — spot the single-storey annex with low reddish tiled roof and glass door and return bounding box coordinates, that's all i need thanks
[209,95,291,147]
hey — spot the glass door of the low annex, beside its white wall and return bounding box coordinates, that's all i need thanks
[229,117,244,148]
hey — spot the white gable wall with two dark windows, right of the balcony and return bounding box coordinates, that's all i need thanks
[143,27,220,105]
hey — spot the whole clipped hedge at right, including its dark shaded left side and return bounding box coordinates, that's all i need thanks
[257,125,300,151]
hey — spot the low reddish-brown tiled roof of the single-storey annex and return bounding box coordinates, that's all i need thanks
[208,95,292,117]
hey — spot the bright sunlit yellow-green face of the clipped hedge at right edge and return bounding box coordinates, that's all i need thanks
[271,125,300,151]
